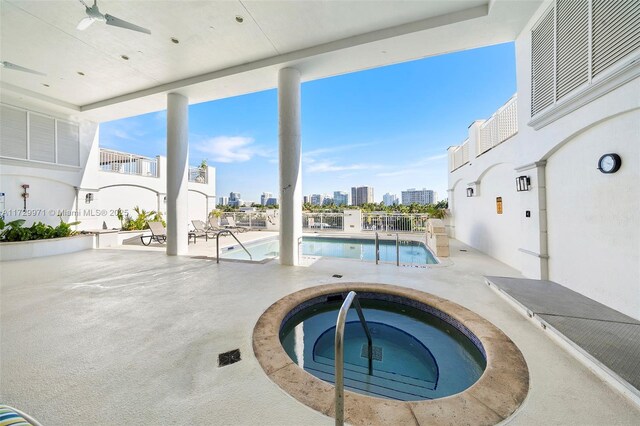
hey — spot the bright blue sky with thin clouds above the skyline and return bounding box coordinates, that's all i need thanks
[100,43,516,202]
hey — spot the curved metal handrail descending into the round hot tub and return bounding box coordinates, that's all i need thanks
[335,291,373,426]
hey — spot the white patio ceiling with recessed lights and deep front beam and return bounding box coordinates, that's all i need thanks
[0,0,541,121]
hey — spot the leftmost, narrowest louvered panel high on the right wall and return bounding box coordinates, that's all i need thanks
[531,8,553,116]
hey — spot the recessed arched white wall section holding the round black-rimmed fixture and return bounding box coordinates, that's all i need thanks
[546,110,640,318]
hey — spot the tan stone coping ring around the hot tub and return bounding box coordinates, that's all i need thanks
[252,282,529,425]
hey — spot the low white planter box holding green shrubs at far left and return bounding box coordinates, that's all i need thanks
[0,235,95,261]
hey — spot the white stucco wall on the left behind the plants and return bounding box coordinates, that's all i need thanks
[0,99,216,230]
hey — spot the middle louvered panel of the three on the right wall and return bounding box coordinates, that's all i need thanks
[556,0,589,99]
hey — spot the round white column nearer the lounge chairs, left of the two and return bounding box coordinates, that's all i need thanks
[167,93,189,256]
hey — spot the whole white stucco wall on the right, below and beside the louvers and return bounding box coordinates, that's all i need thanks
[449,3,640,318]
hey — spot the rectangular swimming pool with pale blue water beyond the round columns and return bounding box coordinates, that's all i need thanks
[220,237,438,265]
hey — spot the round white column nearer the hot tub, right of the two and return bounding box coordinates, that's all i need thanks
[278,68,302,265]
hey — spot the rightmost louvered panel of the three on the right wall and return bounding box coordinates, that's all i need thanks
[591,0,640,76]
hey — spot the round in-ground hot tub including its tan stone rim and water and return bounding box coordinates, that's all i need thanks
[253,283,529,424]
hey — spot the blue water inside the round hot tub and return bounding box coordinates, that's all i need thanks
[280,298,486,401]
